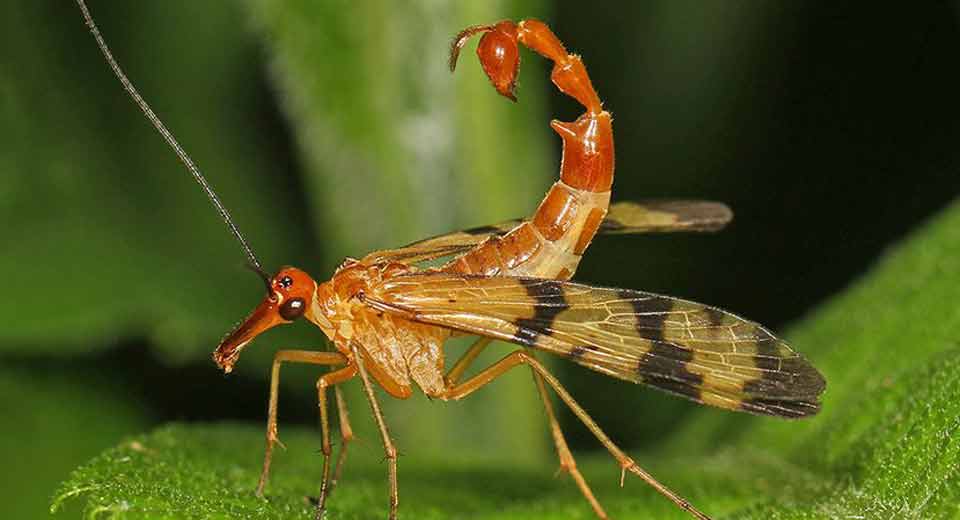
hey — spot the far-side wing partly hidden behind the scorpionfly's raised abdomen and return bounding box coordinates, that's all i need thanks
[364,200,733,264]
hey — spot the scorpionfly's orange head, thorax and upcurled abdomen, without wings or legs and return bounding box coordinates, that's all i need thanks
[214,20,614,399]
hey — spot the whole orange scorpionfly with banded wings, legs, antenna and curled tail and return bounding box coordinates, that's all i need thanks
[77,0,825,519]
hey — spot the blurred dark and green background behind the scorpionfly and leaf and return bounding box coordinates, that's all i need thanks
[0,0,960,518]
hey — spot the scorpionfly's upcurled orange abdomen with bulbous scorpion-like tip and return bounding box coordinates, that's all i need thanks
[442,20,614,279]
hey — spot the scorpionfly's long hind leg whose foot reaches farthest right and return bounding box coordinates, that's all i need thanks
[440,350,710,520]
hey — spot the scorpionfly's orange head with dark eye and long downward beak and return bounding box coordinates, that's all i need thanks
[213,267,317,373]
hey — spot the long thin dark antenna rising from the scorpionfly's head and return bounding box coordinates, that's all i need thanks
[77,0,270,292]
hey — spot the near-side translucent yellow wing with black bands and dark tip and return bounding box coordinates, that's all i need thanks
[365,272,825,418]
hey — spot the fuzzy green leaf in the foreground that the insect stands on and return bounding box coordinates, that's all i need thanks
[54,199,960,519]
